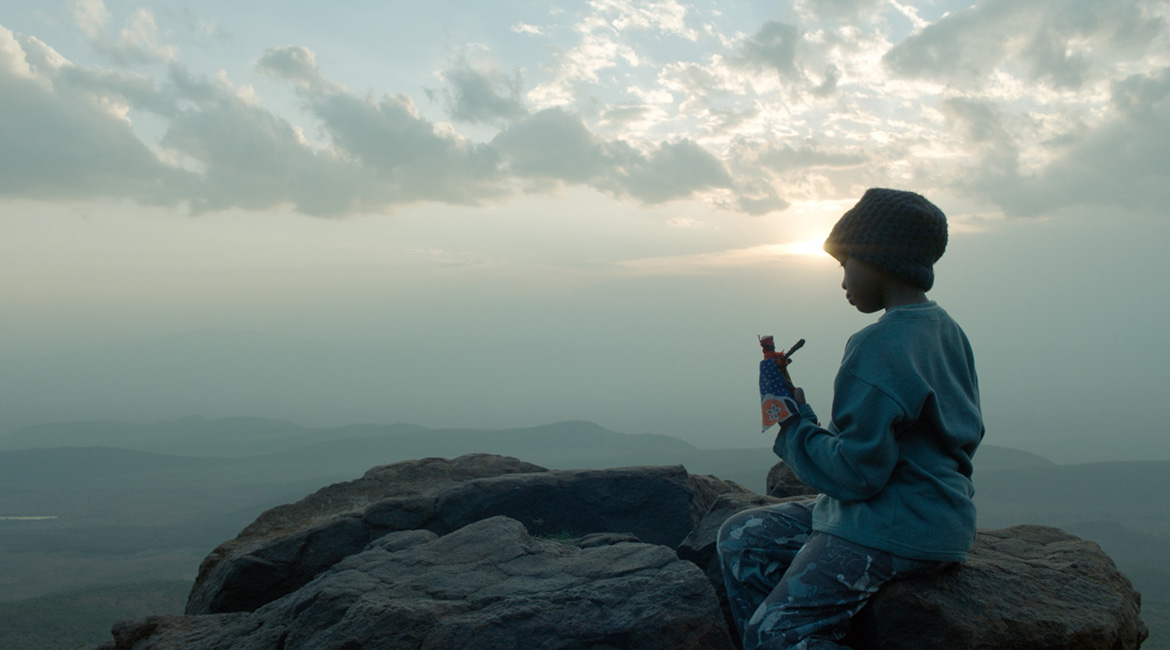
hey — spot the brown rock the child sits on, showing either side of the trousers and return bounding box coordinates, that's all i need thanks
[679,493,1149,650]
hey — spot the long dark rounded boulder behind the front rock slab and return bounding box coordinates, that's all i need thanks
[186,455,748,614]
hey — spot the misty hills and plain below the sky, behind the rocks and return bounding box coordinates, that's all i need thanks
[0,416,1170,650]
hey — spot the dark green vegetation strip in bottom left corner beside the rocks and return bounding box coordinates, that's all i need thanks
[0,580,191,650]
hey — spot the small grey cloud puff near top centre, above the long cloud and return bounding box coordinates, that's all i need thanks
[442,55,528,124]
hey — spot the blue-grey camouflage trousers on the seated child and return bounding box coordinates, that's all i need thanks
[718,502,948,650]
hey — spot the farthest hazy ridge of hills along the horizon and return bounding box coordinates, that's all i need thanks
[0,416,1053,492]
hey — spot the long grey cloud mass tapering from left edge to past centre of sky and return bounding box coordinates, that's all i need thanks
[0,10,748,216]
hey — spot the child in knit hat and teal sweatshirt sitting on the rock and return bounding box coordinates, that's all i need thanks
[718,188,984,650]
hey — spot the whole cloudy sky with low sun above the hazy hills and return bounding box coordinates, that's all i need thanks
[0,0,1170,462]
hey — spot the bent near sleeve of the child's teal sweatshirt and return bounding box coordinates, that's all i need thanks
[772,368,904,502]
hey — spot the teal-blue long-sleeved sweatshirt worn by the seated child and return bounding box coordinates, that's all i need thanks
[773,302,984,561]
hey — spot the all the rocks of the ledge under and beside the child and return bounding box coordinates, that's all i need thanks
[103,455,1147,650]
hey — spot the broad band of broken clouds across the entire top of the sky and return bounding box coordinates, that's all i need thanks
[0,0,1170,217]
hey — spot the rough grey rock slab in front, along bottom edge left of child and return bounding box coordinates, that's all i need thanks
[112,517,734,650]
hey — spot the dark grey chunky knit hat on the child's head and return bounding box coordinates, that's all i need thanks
[825,187,947,291]
